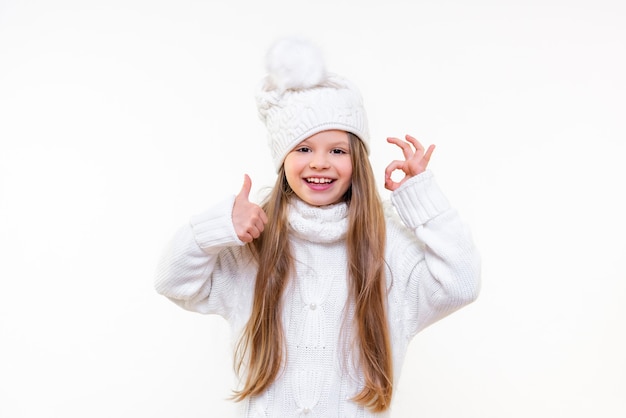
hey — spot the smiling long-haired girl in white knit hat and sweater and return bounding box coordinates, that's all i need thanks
[156,40,480,418]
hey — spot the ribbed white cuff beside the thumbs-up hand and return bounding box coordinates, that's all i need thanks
[190,195,244,249]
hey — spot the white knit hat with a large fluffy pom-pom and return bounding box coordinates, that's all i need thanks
[256,38,369,171]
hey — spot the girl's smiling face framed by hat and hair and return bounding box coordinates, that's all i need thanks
[284,130,352,206]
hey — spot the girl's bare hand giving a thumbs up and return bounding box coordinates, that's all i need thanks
[233,174,267,243]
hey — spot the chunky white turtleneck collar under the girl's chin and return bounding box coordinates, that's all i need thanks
[288,197,348,243]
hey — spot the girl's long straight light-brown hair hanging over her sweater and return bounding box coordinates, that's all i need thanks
[234,134,393,412]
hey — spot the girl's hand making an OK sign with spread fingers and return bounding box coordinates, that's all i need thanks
[385,135,435,191]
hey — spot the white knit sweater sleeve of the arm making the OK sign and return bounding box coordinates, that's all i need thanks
[389,170,480,336]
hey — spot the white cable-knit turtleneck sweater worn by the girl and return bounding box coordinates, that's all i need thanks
[156,171,480,418]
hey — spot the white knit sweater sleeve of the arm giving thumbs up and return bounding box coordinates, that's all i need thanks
[155,196,251,316]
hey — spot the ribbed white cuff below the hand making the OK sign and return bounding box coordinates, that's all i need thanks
[391,170,450,229]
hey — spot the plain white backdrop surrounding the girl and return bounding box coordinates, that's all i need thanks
[0,0,626,418]
